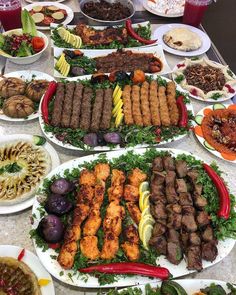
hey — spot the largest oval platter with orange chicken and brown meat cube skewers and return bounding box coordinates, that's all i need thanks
[31,148,236,288]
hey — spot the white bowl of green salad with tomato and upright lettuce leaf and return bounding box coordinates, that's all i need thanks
[0,10,48,64]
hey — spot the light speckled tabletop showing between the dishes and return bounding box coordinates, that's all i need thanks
[0,0,236,295]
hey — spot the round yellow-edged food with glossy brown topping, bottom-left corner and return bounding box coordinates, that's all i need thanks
[0,257,42,295]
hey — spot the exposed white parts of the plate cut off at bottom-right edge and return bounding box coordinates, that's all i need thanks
[117,279,230,295]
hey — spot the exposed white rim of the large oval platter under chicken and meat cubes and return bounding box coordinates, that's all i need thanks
[32,148,235,288]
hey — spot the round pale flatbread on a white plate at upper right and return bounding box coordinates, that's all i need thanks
[163,27,202,51]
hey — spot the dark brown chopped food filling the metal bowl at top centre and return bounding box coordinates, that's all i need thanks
[81,0,131,21]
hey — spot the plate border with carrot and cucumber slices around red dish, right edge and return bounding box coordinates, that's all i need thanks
[194,104,236,163]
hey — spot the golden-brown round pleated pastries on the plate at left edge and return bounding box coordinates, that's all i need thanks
[0,77,49,118]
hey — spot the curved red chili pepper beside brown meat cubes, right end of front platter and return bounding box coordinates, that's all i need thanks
[203,163,230,219]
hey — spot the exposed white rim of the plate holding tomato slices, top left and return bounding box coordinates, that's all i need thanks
[24,1,74,31]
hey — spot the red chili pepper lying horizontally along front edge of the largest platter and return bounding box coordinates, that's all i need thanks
[79,262,170,280]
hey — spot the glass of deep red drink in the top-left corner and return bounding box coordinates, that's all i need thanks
[0,0,21,31]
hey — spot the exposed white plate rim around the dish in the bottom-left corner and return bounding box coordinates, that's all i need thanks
[0,245,55,295]
